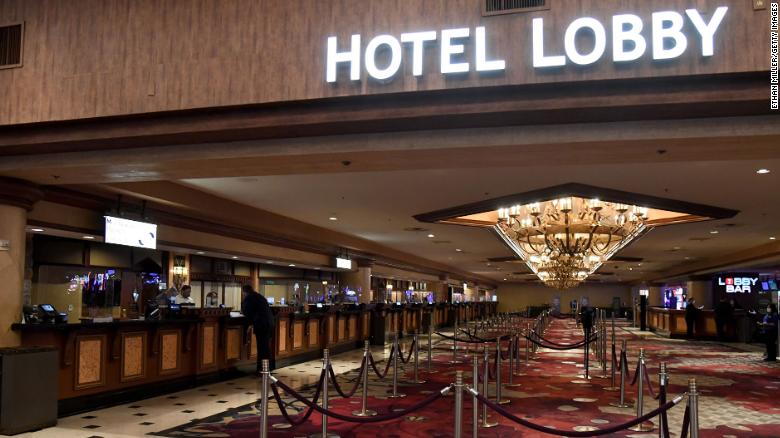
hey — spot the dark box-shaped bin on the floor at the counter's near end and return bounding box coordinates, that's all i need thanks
[0,347,58,435]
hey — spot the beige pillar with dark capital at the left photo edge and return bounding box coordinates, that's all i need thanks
[0,177,43,347]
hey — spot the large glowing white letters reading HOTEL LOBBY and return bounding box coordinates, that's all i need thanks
[326,6,728,83]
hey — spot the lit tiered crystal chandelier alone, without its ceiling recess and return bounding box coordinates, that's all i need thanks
[496,197,648,289]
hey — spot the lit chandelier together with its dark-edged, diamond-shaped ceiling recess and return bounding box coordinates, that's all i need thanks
[415,183,739,289]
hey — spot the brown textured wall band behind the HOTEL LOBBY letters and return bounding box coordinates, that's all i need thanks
[0,0,769,125]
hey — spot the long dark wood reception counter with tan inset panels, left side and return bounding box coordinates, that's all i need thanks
[12,303,496,416]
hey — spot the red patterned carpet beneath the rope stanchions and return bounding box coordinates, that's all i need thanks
[156,320,780,438]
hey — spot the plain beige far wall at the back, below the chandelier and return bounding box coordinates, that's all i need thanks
[498,283,631,312]
